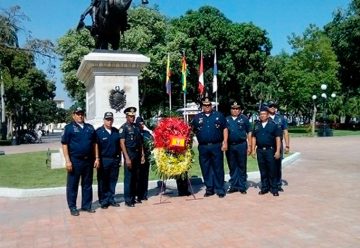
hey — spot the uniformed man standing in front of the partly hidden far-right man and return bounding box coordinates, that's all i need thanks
[251,106,281,196]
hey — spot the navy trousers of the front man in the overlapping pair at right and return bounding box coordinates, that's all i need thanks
[256,147,278,193]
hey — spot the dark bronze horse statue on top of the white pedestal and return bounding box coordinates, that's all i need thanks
[76,0,148,50]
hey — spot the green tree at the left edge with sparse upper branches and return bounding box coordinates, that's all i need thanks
[0,6,56,138]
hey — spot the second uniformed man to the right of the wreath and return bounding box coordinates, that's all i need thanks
[226,101,251,194]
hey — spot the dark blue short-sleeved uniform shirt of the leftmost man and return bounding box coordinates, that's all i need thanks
[61,121,96,157]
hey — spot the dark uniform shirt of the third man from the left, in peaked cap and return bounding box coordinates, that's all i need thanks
[120,122,142,149]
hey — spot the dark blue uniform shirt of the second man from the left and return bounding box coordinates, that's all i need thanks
[96,126,120,158]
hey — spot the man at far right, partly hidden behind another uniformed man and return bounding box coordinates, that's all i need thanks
[268,101,290,192]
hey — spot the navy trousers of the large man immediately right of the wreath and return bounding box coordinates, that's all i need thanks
[198,143,225,194]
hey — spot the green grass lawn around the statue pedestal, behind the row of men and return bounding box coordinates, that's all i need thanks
[0,148,258,188]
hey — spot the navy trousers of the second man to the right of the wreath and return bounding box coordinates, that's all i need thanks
[226,141,247,191]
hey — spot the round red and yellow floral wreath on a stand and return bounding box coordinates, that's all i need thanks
[152,118,193,179]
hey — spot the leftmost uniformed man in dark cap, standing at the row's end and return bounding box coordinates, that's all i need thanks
[61,108,99,216]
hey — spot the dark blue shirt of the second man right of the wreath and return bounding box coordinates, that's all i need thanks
[226,114,250,144]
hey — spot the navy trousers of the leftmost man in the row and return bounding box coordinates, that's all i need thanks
[66,157,94,210]
